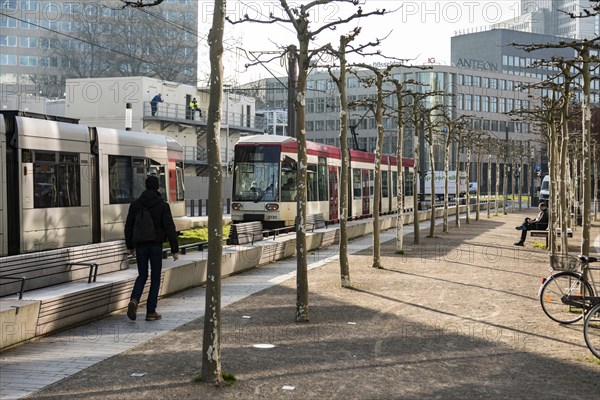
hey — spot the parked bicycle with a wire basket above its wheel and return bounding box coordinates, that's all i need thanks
[539,254,600,324]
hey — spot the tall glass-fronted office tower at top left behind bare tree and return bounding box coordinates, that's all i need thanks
[0,0,198,98]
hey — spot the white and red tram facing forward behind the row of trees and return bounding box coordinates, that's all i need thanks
[231,135,414,228]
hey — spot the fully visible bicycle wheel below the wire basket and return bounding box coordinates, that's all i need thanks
[540,271,593,324]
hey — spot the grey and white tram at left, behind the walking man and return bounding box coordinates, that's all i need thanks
[0,111,185,255]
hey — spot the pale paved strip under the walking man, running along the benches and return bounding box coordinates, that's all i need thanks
[0,217,398,399]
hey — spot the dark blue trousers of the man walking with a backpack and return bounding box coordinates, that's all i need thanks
[131,243,162,313]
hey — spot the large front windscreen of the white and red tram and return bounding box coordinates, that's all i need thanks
[233,146,281,202]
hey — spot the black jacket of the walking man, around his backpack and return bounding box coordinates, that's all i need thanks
[125,190,179,253]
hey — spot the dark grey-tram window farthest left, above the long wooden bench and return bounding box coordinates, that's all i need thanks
[33,151,81,208]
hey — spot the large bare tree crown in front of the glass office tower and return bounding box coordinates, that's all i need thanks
[46,2,197,85]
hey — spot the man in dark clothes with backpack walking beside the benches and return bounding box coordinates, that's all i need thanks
[125,176,179,321]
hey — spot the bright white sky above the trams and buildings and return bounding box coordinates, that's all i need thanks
[199,0,520,83]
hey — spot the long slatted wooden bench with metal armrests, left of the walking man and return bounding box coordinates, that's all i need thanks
[0,240,128,297]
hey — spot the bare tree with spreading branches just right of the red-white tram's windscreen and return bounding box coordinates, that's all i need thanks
[230,0,386,322]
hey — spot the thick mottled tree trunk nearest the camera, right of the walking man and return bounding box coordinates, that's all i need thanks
[201,0,225,385]
